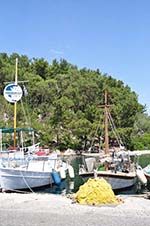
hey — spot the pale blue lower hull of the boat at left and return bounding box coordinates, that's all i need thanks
[0,168,53,191]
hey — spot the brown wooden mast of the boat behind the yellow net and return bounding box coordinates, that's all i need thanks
[104,90,109,154]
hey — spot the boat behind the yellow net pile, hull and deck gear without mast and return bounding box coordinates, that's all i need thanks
[79,152,137,190]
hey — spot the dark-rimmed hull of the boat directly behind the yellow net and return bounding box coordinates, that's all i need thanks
[80,171,137,190]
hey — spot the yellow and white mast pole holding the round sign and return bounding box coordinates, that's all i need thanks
[14,58,18,148]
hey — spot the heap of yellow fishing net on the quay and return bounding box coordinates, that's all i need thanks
[75,178,121,205]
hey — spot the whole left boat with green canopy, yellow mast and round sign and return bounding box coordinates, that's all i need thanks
[0,59,67,191]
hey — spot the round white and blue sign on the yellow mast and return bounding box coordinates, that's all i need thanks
[4,83,23,103]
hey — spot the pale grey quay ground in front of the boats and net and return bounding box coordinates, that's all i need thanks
[0,193,150,226]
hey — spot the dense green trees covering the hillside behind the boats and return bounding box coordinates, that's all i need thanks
[0,53,146,150]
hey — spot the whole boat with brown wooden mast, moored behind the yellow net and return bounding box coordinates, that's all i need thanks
[79,90,146,190]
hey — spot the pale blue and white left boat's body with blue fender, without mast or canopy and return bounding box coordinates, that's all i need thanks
[0,154,68,191]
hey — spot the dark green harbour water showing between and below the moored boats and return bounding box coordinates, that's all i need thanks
[38,155,150,194]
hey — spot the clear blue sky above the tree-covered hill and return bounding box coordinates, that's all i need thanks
[0,0,150,114]
